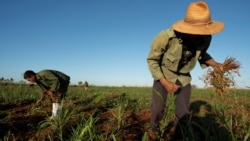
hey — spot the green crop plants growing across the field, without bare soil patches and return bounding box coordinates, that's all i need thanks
[0,85,250,141]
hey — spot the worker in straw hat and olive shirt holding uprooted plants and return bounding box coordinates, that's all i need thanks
[147,1,224,140]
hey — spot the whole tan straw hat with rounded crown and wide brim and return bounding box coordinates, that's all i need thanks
[173,2,224,35]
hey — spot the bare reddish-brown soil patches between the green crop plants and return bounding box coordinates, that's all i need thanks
[0,95,244,141]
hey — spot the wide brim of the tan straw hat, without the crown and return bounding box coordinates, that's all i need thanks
[173,20,224,35]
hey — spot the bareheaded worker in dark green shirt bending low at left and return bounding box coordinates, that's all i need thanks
[24,70,70,119]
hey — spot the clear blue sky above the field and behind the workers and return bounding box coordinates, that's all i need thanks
[0,0,250,87]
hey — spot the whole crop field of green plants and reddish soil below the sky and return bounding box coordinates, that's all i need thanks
[0,84,250,141]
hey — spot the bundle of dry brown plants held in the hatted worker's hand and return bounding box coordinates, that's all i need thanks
[203,57,240,97]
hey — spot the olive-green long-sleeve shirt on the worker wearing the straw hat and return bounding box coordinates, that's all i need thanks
[147,28,212,86]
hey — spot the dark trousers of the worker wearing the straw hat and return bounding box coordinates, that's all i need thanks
[150,80,191,126]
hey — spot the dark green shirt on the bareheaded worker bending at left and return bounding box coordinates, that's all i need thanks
[36,70,70,91]
